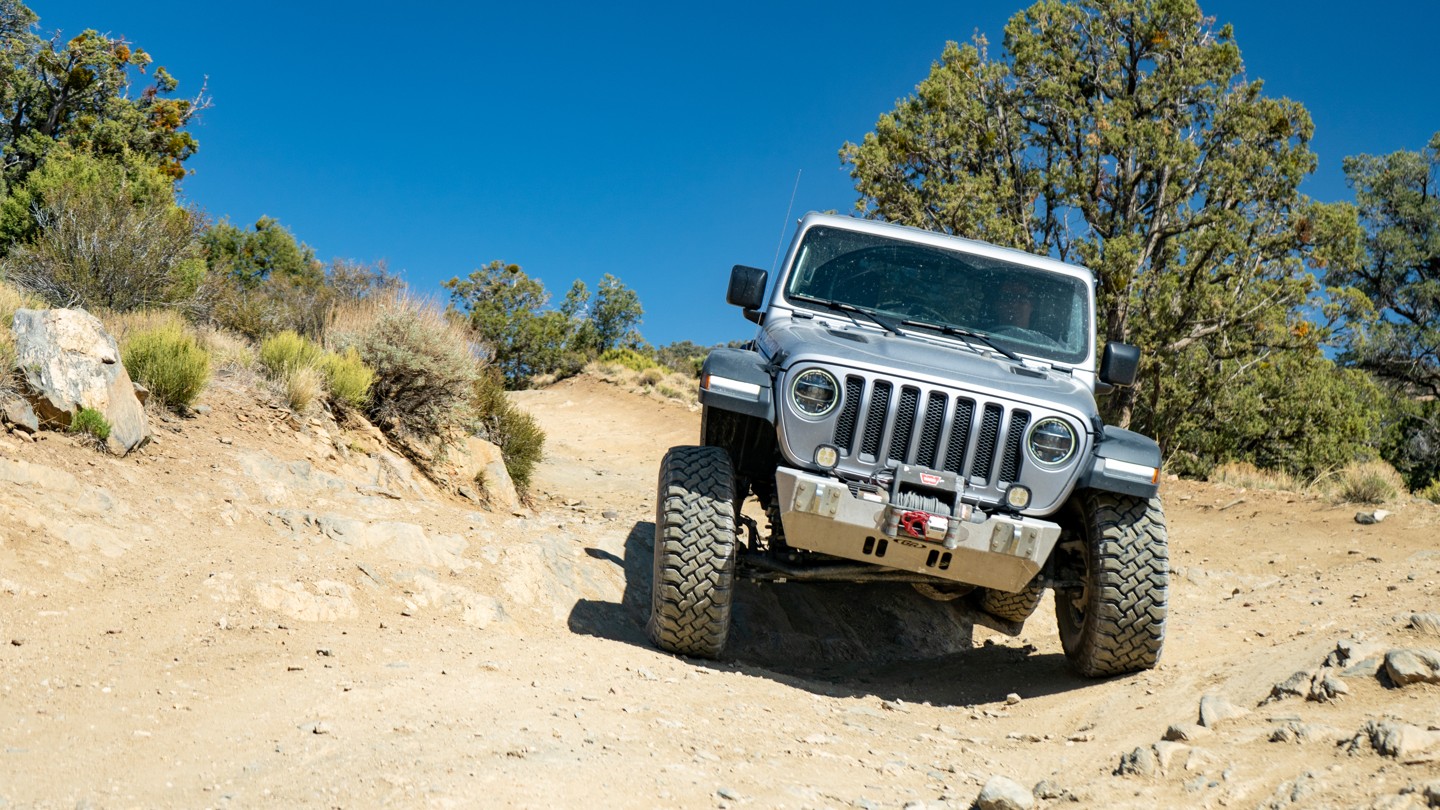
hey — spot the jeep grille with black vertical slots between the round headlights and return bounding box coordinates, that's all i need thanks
[834,375,1031,487]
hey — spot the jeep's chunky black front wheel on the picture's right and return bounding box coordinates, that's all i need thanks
[1056,491,1169,677]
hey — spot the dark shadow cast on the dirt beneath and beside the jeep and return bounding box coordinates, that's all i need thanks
[569,522,1093,706]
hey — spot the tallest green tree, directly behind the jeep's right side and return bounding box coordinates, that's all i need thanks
[841,0,1345,467]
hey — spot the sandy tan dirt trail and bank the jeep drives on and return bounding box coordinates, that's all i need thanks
[0,378,1440,807]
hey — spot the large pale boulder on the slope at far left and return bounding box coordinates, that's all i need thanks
[13,310,150,455]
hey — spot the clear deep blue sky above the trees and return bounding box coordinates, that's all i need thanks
[30,0,1440,344]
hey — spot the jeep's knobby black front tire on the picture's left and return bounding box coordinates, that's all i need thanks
[647,447,736,659]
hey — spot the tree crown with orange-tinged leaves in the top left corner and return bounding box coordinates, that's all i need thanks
[0,7,209,186]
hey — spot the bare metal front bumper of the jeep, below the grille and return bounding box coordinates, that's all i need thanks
[775,467,1060,592]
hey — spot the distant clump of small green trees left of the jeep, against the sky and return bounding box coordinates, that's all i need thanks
[444,261,642,388]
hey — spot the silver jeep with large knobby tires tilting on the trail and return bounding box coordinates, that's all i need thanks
[648,213,1169,676]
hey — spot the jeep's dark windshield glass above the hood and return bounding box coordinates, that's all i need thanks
[785,220,1090,363]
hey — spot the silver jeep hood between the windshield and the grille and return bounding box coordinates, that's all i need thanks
[759,319,1097,419]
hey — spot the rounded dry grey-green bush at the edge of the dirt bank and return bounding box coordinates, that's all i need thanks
[331,297,480,442]
